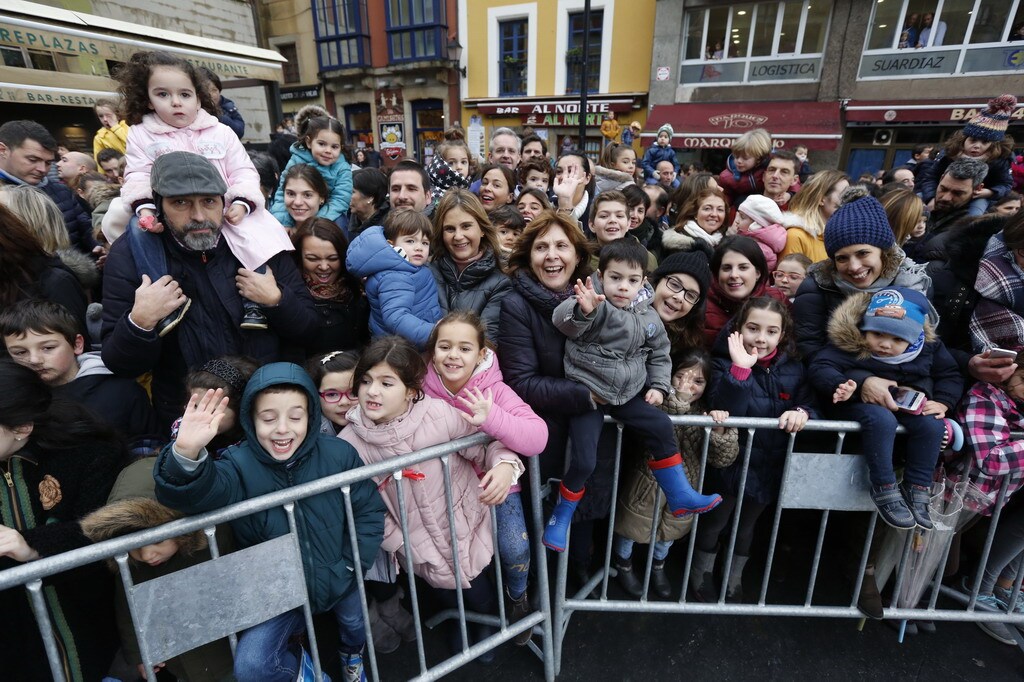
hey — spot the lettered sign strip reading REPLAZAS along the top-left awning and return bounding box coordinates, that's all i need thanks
[0,16,280,81]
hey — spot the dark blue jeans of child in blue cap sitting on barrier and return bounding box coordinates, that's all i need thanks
[833,402,945,486]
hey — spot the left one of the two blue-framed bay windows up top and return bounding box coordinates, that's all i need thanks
[315,0,370,71]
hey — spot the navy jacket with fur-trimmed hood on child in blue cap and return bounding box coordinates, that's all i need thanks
[807,294,964,412]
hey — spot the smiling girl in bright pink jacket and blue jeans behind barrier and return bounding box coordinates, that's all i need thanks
[423,310,548,646]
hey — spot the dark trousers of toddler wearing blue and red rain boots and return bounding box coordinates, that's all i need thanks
[562,393,679,492]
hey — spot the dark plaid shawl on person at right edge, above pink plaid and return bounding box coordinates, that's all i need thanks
[970,232,1024,352]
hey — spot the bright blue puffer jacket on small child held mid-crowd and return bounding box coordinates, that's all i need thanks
[345,225,441,350]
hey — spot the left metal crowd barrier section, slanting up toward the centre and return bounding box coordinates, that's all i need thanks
[0,434,555,682]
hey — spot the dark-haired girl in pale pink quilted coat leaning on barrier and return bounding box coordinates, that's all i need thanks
[339,336,523,650]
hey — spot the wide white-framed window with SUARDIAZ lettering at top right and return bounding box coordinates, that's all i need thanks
[860,0,1024,79]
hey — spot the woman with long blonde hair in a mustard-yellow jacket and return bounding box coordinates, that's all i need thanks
[778,170,850,263]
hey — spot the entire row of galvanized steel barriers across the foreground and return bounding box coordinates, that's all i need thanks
[0,416,1024,681]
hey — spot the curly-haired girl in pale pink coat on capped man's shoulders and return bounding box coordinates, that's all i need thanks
[118,52,294,336]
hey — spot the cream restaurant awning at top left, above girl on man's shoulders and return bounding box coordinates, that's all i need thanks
[0,0,287,106]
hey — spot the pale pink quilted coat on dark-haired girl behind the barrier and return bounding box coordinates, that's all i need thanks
[338,396,521,590]
